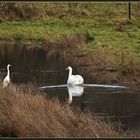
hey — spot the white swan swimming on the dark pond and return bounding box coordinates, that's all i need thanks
[66,66,84,85]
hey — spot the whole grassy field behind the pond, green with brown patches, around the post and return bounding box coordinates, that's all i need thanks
[0,3,140,52]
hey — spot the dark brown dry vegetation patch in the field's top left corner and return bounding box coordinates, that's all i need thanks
[0,3,45,21]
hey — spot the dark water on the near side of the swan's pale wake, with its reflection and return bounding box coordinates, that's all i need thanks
[40,84,140,133]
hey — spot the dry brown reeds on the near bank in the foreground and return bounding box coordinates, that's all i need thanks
[0,78,126,137]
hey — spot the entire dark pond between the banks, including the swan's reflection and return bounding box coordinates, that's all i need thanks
[0,44,140,133]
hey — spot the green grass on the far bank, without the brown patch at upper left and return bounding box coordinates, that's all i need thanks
[0,3,140,52]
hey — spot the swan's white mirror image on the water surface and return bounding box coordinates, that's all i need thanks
[67,85,84,104]
